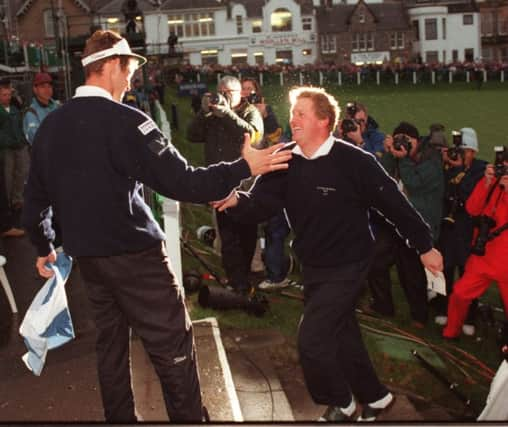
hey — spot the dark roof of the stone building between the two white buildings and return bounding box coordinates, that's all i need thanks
[316,3,409,34]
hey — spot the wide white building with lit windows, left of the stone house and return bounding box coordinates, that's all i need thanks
[139,0,316,65]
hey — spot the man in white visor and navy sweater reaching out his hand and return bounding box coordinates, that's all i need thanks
[23,30,290,423]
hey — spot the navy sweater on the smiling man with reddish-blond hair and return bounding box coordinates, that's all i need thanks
[230,140,432,268]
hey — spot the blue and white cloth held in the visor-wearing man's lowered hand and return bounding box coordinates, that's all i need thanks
[19,252,74,375]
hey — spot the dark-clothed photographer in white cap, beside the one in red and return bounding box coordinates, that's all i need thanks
[435,128,487,335]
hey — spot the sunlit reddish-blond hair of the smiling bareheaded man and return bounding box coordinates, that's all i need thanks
[289,86,340,132]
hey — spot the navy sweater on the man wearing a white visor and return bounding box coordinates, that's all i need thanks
[23,96,250,256]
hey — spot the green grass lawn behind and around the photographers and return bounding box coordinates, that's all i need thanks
[162,83,508,415]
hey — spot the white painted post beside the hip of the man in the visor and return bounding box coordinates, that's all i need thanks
[162,198,183,285]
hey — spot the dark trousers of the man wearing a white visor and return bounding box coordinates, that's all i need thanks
[78,242,202,423]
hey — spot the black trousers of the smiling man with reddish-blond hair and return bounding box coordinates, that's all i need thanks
[298,261,388,408]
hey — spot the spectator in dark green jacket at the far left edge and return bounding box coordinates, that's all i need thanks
[0,80,30,214]
